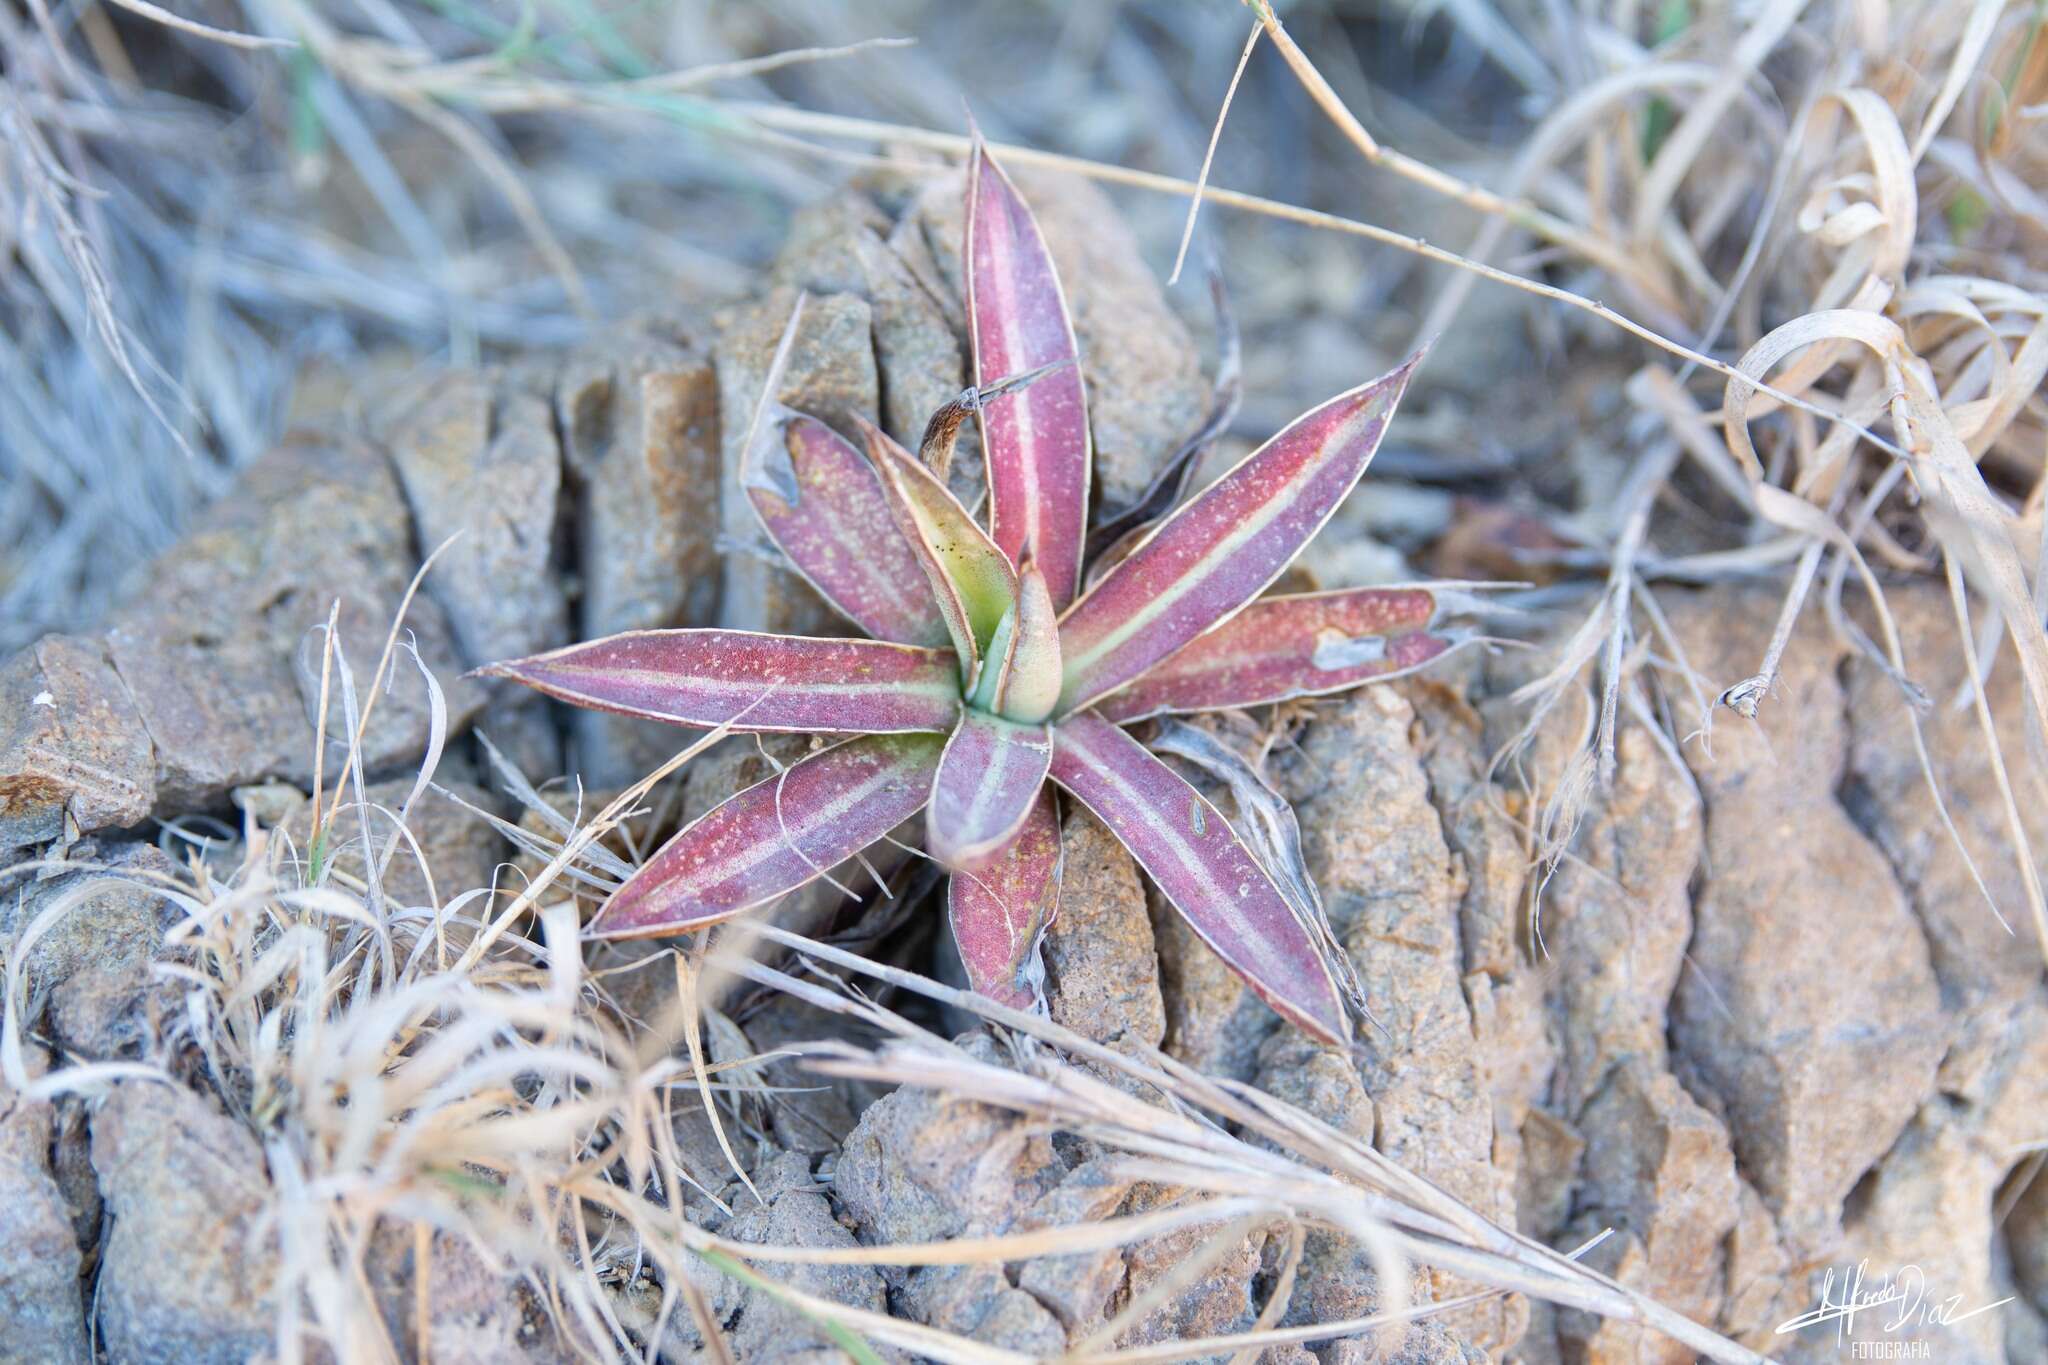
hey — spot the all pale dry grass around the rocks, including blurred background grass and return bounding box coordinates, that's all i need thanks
[12,0,2048,1359]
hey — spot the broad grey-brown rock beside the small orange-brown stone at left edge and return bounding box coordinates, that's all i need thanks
[106,436,481,814]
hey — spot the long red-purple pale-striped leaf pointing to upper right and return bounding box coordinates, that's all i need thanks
[1059,356,1419,712]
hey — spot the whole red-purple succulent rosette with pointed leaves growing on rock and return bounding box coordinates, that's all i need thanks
[485,143,1448,1042]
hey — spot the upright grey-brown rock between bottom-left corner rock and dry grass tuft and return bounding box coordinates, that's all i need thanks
[92,1081,279,1365]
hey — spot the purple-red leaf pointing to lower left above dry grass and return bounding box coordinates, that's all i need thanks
[590,735,944,939]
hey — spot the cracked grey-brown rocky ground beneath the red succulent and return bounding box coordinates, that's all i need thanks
[0,165,2048,1365]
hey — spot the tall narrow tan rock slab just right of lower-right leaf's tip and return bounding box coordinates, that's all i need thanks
[1276,688,1513,1347]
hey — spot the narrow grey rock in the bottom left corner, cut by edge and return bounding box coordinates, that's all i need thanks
[0,1046,92,1365]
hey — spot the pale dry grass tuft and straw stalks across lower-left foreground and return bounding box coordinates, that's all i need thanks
[0,626,1761,1365]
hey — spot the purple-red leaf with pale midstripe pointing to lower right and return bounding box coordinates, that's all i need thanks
[1053,712,1350,1044]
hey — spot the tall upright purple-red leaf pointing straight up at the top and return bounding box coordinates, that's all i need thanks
[965,139,1090,608]
